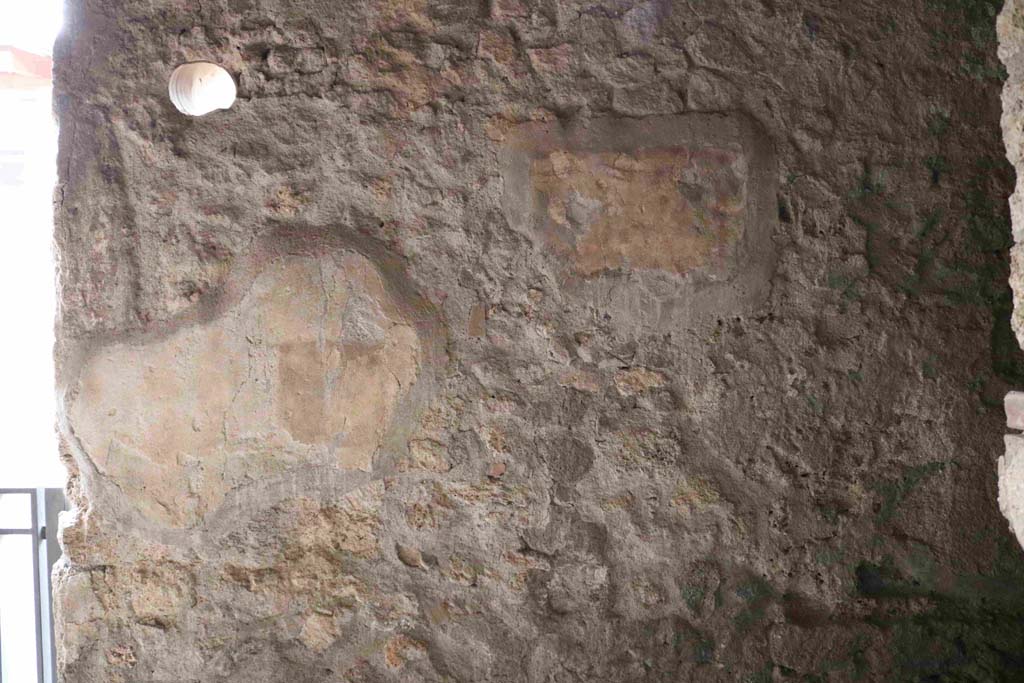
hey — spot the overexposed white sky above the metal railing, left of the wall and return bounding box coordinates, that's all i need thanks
[0,0,65,487]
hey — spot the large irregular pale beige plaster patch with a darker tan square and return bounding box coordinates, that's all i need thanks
[69,252,421,526]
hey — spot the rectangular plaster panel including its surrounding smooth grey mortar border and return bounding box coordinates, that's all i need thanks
[502,115,775,331]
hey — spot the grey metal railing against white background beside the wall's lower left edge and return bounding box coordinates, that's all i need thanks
[0,488,67,683]
